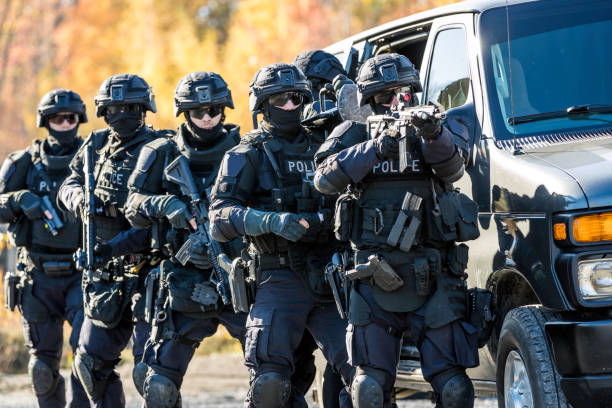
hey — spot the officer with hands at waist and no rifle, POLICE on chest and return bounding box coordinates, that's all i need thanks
[210,63,352,407]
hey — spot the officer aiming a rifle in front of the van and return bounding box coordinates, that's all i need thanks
[314,54,478,408]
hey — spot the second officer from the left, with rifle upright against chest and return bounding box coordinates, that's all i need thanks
[59,74,165,407]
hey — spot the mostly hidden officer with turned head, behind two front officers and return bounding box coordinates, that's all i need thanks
[293,50,346,407]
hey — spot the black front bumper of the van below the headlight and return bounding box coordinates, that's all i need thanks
[545,320,612,408]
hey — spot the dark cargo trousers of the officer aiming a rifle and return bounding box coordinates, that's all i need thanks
[346,281,478,403]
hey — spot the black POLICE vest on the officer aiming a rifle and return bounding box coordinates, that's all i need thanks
[350,132,440,248]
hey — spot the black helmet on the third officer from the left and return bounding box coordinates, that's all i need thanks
[174,71,234,116]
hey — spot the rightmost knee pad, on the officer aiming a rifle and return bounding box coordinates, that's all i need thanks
[431,369,474,408]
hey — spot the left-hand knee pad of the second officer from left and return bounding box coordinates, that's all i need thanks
[73,349,114,401]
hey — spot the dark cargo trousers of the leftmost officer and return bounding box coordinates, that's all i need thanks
[22,269,89,408]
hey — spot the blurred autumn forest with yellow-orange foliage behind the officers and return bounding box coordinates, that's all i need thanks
[0,0,454,160]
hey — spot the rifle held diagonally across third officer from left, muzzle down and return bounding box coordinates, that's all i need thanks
[164,155,231,305]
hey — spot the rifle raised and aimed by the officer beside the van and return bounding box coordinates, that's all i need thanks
[366,103,446,173]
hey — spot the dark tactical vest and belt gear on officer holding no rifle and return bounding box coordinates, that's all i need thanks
[247,130,341,303]
